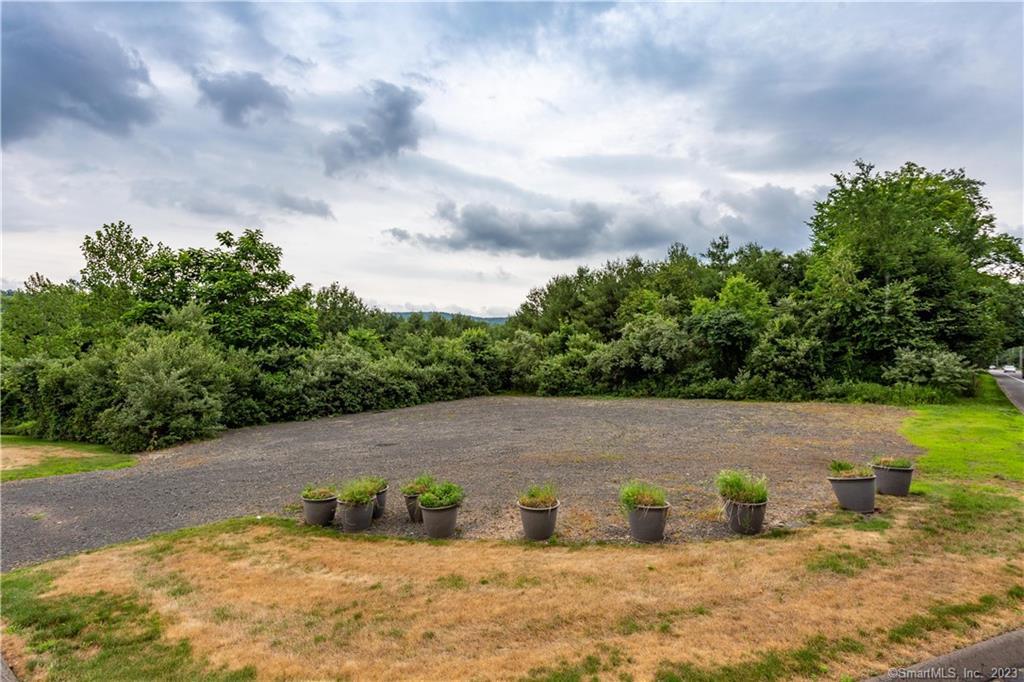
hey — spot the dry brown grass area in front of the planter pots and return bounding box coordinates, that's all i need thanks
[28,503,1024,680]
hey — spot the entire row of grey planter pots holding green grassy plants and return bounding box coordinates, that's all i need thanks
[302,458,913,543]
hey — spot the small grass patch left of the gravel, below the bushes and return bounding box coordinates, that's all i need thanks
[0,435,135,481]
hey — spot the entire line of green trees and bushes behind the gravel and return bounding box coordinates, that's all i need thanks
[0,162,1024,452]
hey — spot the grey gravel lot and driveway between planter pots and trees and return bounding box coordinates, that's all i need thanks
[0,396,916,570]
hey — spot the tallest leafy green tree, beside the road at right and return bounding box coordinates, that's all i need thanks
[810,162,1024,364]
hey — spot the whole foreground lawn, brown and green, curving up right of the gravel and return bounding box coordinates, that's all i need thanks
[0,377,1024,682]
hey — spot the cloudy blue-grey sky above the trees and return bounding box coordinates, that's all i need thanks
[2,3,1024,314]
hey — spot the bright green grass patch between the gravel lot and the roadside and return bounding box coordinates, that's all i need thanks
[903,374,1024,481]
